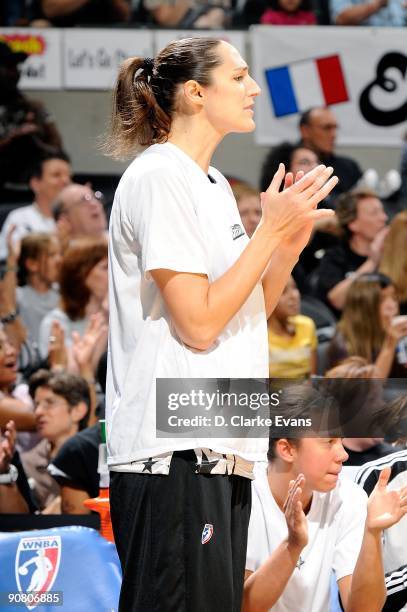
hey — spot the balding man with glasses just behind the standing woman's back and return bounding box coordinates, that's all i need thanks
[53,183,107,251]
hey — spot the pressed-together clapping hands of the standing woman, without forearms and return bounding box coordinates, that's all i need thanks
[260,164,338,250]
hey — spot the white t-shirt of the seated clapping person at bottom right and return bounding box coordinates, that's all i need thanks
[246,464,367,612]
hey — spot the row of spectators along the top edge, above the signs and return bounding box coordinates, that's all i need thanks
[0,0,406,29]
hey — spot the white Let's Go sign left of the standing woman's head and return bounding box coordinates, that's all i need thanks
[64,28,153,89]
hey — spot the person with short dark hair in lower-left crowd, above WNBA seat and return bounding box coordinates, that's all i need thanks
[21,370,90,513]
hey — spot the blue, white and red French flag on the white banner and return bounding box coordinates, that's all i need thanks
[265,55,349,117]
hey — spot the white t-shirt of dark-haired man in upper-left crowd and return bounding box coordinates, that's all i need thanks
[0,202,56,259]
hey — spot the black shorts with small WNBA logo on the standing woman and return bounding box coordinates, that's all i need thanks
[110,451,251,612]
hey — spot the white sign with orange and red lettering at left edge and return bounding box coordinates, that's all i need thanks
[0,28,62,89]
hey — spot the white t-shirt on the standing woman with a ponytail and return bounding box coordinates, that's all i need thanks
[106,143,268,466]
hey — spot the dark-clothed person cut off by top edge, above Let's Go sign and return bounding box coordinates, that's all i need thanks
[37,0,131,28]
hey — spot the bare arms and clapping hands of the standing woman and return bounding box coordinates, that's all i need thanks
[151,166,337,350]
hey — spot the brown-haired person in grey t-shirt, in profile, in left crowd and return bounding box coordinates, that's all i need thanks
[17,233,61,346]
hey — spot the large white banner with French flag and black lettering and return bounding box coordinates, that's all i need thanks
[250,26,407,146]
